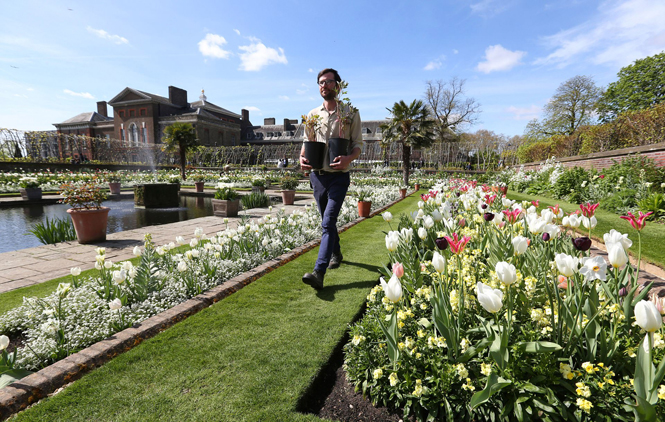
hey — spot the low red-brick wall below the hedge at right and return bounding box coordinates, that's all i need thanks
[524,142,665,170]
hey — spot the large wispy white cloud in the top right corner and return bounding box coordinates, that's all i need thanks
[534,0,665,67]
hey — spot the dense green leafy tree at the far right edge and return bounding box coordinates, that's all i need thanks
[598,52,665,122]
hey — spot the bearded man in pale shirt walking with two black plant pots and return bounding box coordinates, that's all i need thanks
[300,69,363,290]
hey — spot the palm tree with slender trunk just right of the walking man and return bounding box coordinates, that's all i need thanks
[381,100,434,186]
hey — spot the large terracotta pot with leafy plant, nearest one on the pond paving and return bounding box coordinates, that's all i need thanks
[60,181,110,243]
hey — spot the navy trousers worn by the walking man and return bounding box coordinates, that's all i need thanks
[309,172,351,274]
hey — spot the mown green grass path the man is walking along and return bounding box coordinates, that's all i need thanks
[7,195,419,422]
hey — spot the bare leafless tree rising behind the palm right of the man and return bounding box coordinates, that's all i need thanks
[425,77,480,141]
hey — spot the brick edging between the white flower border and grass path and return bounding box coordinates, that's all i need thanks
[0,199,401,421]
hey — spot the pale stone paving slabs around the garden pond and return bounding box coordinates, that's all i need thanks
[0,189,314,293]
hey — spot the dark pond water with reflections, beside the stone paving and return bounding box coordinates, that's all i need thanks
[0,196,213,253]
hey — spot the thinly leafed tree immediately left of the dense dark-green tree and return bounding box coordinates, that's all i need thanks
[525,75,603,139]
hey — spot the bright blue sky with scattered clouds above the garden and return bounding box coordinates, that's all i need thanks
[0,0,665,136]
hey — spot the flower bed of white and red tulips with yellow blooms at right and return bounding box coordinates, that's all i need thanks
[344,180,665,421]
